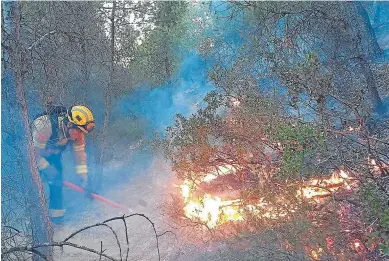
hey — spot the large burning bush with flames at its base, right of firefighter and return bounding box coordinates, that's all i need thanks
[165,64,387,260]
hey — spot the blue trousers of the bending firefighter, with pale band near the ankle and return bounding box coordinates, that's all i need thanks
[41,153,65,223]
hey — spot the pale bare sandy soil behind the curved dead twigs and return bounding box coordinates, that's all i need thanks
[54,156,206,261]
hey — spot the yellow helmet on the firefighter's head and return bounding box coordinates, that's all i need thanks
[68,105,95,133]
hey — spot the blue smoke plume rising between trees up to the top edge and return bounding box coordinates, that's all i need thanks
[112,2,247,134]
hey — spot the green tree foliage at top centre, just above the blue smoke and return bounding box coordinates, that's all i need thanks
[131,1,188,85]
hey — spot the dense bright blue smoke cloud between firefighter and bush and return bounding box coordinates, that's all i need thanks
[112,52,215,137]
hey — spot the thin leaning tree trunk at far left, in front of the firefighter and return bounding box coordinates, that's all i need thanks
[7,2,53,260]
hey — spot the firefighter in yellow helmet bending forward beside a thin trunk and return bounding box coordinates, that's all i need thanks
[32,105,95,224]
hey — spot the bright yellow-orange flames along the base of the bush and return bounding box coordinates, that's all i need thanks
[180,165,351,228]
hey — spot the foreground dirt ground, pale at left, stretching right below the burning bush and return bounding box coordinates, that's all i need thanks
[54,155,302,261]
